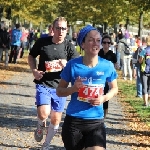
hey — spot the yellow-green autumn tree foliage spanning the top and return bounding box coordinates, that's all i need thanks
[0,0,150,34]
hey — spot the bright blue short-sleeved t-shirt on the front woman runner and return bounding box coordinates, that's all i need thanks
[61,56,117,119]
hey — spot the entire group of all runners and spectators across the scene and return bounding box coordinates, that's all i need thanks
[0,17,150,150]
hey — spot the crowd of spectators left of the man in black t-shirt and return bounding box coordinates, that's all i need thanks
[0,23,53,66]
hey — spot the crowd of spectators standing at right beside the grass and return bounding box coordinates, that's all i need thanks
[103,25,150,107]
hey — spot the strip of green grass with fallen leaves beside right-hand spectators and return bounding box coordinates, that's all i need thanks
[118,79,150,126]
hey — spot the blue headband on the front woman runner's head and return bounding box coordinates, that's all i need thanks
[77,25,97,47]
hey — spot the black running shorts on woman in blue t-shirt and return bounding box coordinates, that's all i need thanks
[62,115,106,150]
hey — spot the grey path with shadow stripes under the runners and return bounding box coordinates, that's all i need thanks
[0,72,131,150]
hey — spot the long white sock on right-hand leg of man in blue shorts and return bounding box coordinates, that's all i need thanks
[45,123,59,144]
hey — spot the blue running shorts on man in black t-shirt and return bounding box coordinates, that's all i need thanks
[35,84,66,112]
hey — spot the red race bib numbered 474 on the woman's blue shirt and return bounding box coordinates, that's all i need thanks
[77,85,104,102]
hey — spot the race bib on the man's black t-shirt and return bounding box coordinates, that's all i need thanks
[45,60,62,72]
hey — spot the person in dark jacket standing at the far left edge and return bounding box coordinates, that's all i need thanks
[0,27,10,66]
